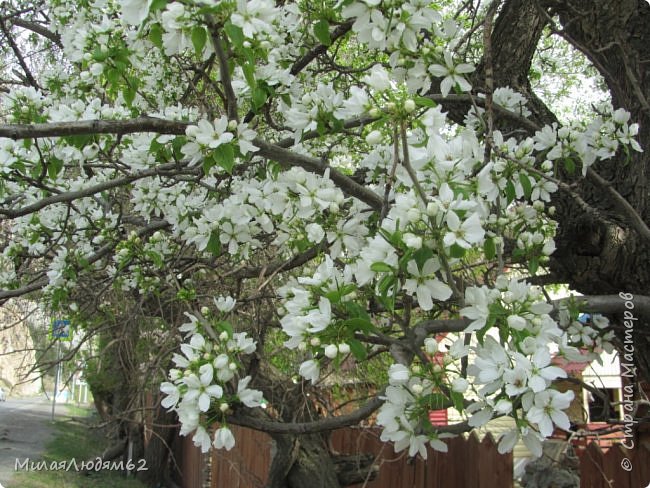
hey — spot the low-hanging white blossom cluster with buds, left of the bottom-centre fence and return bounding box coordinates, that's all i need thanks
[160,297,264,452]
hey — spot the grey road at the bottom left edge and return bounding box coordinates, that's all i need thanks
[0,397,55,486]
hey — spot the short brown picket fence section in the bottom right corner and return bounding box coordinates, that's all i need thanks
[580,442,650,488]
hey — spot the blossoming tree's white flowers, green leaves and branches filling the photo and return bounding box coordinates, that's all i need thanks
[0,0,648,486]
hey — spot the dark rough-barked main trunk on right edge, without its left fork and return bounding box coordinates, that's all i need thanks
[541,0,650,379]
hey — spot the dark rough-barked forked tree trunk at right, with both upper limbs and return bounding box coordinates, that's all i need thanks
[434,0,650,379]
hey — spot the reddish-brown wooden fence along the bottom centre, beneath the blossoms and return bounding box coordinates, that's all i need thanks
[199,427,513,488]
